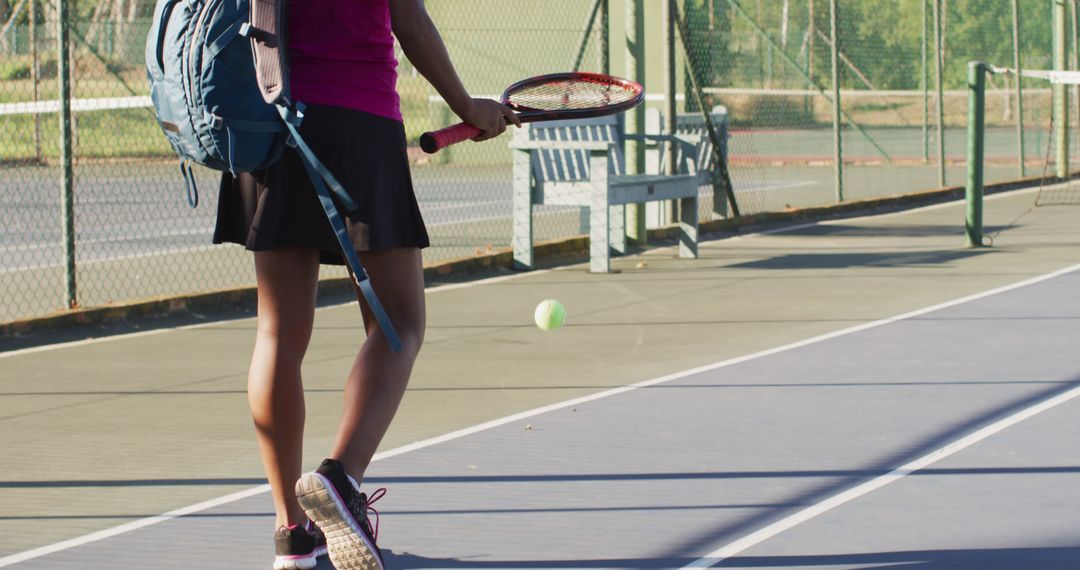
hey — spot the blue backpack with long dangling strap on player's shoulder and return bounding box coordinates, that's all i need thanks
[139,0,401,352]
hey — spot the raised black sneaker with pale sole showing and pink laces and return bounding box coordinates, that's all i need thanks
[296,459,387,570]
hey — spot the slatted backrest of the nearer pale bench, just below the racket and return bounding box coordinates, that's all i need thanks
[514,116,626,185]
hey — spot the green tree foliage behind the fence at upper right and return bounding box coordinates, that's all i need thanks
[708,0,1054,90]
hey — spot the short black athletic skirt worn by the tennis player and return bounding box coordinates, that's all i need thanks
[214,105,430,264]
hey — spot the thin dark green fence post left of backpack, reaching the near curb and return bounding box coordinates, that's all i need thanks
[56,0,79,309]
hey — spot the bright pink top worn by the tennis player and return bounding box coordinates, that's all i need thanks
[288,0,402,121]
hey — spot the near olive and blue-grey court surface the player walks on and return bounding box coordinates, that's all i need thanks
[0,185,1080,569]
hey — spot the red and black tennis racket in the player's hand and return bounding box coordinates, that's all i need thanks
[420,72,645,154]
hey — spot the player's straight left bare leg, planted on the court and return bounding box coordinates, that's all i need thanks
[247,249,319,527]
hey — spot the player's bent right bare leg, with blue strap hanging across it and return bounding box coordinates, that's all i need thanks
[330,248,426,481]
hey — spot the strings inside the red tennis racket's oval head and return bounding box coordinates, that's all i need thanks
[507,80,638,111]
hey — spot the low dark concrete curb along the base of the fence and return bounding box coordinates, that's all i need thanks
[0,176,1057,339]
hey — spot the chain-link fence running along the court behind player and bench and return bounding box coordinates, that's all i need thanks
[0,0,1080,323]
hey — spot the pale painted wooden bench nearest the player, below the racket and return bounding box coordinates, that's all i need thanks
[510,117,707,273]
